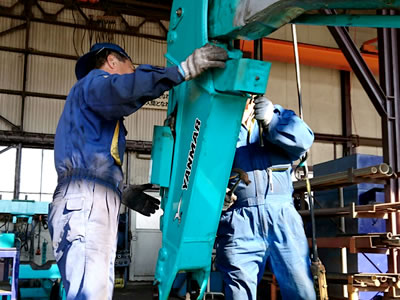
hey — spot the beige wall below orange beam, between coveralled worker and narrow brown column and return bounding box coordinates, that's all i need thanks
[267,62,342,165]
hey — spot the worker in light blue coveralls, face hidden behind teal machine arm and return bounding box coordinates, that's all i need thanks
[216,97,316,300]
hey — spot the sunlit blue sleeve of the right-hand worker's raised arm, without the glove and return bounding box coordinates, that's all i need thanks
[264,105,314,161]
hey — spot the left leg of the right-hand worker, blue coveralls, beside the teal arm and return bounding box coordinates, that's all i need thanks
[216,206,267,300]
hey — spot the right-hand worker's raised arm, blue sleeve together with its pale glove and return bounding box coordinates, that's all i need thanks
[254,97,314,161]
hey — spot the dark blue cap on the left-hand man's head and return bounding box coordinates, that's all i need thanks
[75,43,131,80]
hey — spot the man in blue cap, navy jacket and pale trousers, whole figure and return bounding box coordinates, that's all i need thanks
[49,43,228,300]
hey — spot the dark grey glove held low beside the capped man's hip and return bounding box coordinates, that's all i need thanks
[121,183,160,217]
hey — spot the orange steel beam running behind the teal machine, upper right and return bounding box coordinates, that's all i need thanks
[240,38,379,74]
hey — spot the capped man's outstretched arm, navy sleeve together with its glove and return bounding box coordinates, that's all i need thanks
[85,44,228,120]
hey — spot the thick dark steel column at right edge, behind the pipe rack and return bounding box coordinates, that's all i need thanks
[378,10,400,273]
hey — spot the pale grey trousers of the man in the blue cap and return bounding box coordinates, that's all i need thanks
[49,181,120,300]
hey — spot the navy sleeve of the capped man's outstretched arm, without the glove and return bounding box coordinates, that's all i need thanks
[85,65,184,120]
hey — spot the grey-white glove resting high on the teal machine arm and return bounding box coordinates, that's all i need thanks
[181,44,228,80]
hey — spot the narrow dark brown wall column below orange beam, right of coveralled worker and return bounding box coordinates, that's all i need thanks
[340,71,354,156]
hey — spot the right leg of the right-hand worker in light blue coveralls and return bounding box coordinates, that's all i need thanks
[266,199,316,300]
